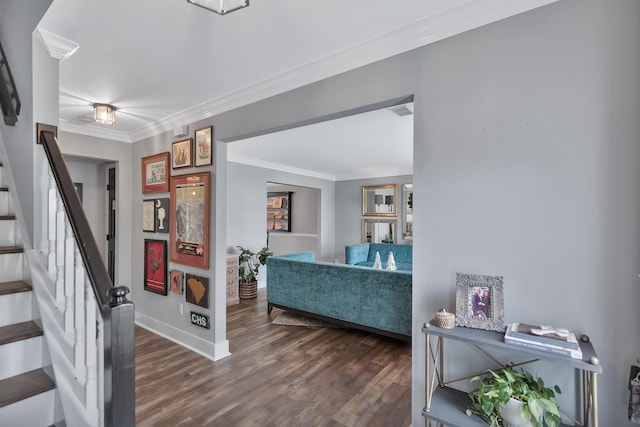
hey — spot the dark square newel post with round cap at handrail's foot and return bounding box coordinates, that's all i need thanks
[104,286,136,427]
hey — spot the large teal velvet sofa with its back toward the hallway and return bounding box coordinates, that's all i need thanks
[267,252,412,341]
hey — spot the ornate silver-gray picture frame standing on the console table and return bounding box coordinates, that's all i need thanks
[456,273,505,332]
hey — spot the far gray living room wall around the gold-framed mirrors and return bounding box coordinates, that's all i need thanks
[336,175,413,262]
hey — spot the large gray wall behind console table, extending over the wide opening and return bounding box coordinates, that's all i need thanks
[208,0,640,425]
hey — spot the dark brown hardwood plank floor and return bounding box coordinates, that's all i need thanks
[136,290,411,427]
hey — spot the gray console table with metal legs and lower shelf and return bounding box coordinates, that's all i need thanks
[422,321,602,427]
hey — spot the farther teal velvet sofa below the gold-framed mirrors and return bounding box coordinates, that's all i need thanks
[345,243,413,271]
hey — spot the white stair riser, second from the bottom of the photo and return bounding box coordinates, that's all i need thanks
[0,336,43,382]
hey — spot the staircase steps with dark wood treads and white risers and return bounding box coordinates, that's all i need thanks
[0,164,64,427]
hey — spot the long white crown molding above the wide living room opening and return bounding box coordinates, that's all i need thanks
[87,0,558,142]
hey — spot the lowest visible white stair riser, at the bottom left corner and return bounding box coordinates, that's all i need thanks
[0,390,55,427]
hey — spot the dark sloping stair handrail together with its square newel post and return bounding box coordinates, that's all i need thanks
[38,128,135,427]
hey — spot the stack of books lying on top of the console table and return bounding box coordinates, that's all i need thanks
[504,323,582,359]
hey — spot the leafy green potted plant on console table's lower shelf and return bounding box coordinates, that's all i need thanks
[467,365,561,427]
